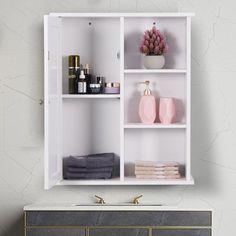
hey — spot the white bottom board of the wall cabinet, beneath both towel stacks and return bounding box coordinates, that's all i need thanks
[57,176,194,186]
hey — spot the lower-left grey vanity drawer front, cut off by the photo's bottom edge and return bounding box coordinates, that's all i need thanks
[26,228,86,236]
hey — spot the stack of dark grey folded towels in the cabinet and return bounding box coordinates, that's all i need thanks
[63,153,120,179]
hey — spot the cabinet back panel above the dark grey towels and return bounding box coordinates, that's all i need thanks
[63,99,120,156]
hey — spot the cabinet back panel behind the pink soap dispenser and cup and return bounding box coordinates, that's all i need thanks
[125,74,186,123]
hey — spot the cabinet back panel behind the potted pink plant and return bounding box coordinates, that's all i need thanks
[125,17,187,69]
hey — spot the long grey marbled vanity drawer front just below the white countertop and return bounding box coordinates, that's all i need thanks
[26,211,211,226]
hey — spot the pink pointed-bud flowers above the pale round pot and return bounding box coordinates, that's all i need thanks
[139,23,168,55]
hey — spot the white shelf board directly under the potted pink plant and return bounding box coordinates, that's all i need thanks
[124,69,187,74]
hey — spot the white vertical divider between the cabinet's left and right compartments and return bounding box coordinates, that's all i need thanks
[120,16,125,181]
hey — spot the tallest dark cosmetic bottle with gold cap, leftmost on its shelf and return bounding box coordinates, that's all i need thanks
[68,55,80,94]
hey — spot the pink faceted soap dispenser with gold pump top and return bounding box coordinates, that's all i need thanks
[139,81,156,124]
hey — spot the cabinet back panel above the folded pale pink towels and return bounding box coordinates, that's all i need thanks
[125,129,186,176]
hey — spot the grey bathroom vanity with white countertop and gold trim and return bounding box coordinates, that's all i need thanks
[24,204,212,236]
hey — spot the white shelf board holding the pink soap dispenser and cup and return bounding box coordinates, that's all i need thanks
[124,123,186,129]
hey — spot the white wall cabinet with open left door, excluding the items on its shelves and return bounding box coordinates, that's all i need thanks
[44,13,194,189]
